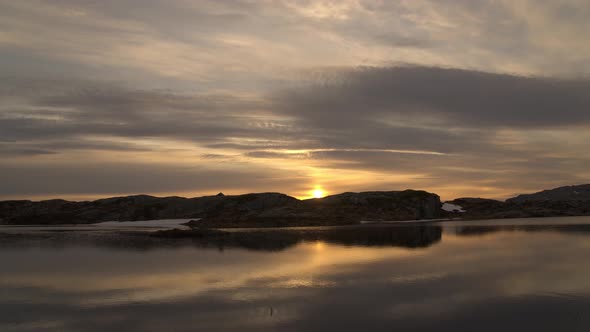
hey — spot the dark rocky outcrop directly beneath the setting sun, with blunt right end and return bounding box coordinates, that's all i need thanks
[194,190,441,227]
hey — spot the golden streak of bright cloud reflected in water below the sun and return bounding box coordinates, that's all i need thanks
[0,243,411,305]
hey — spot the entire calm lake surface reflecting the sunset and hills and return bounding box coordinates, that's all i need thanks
[0,217,590,332]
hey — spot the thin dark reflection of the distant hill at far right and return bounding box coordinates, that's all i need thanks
[452,224,590,236]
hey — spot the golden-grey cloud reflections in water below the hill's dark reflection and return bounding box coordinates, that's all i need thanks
[0,226,590,331]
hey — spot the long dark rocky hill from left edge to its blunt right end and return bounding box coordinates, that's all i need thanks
[0,190,441,227]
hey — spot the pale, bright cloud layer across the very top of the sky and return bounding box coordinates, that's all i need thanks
[0,0,590,90]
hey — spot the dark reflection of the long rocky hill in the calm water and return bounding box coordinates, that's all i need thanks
[0,225,442,251]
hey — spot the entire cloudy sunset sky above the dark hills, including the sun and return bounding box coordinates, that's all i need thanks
[0,0,590,200]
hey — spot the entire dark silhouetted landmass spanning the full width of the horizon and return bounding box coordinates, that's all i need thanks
[0,185,590,228]
